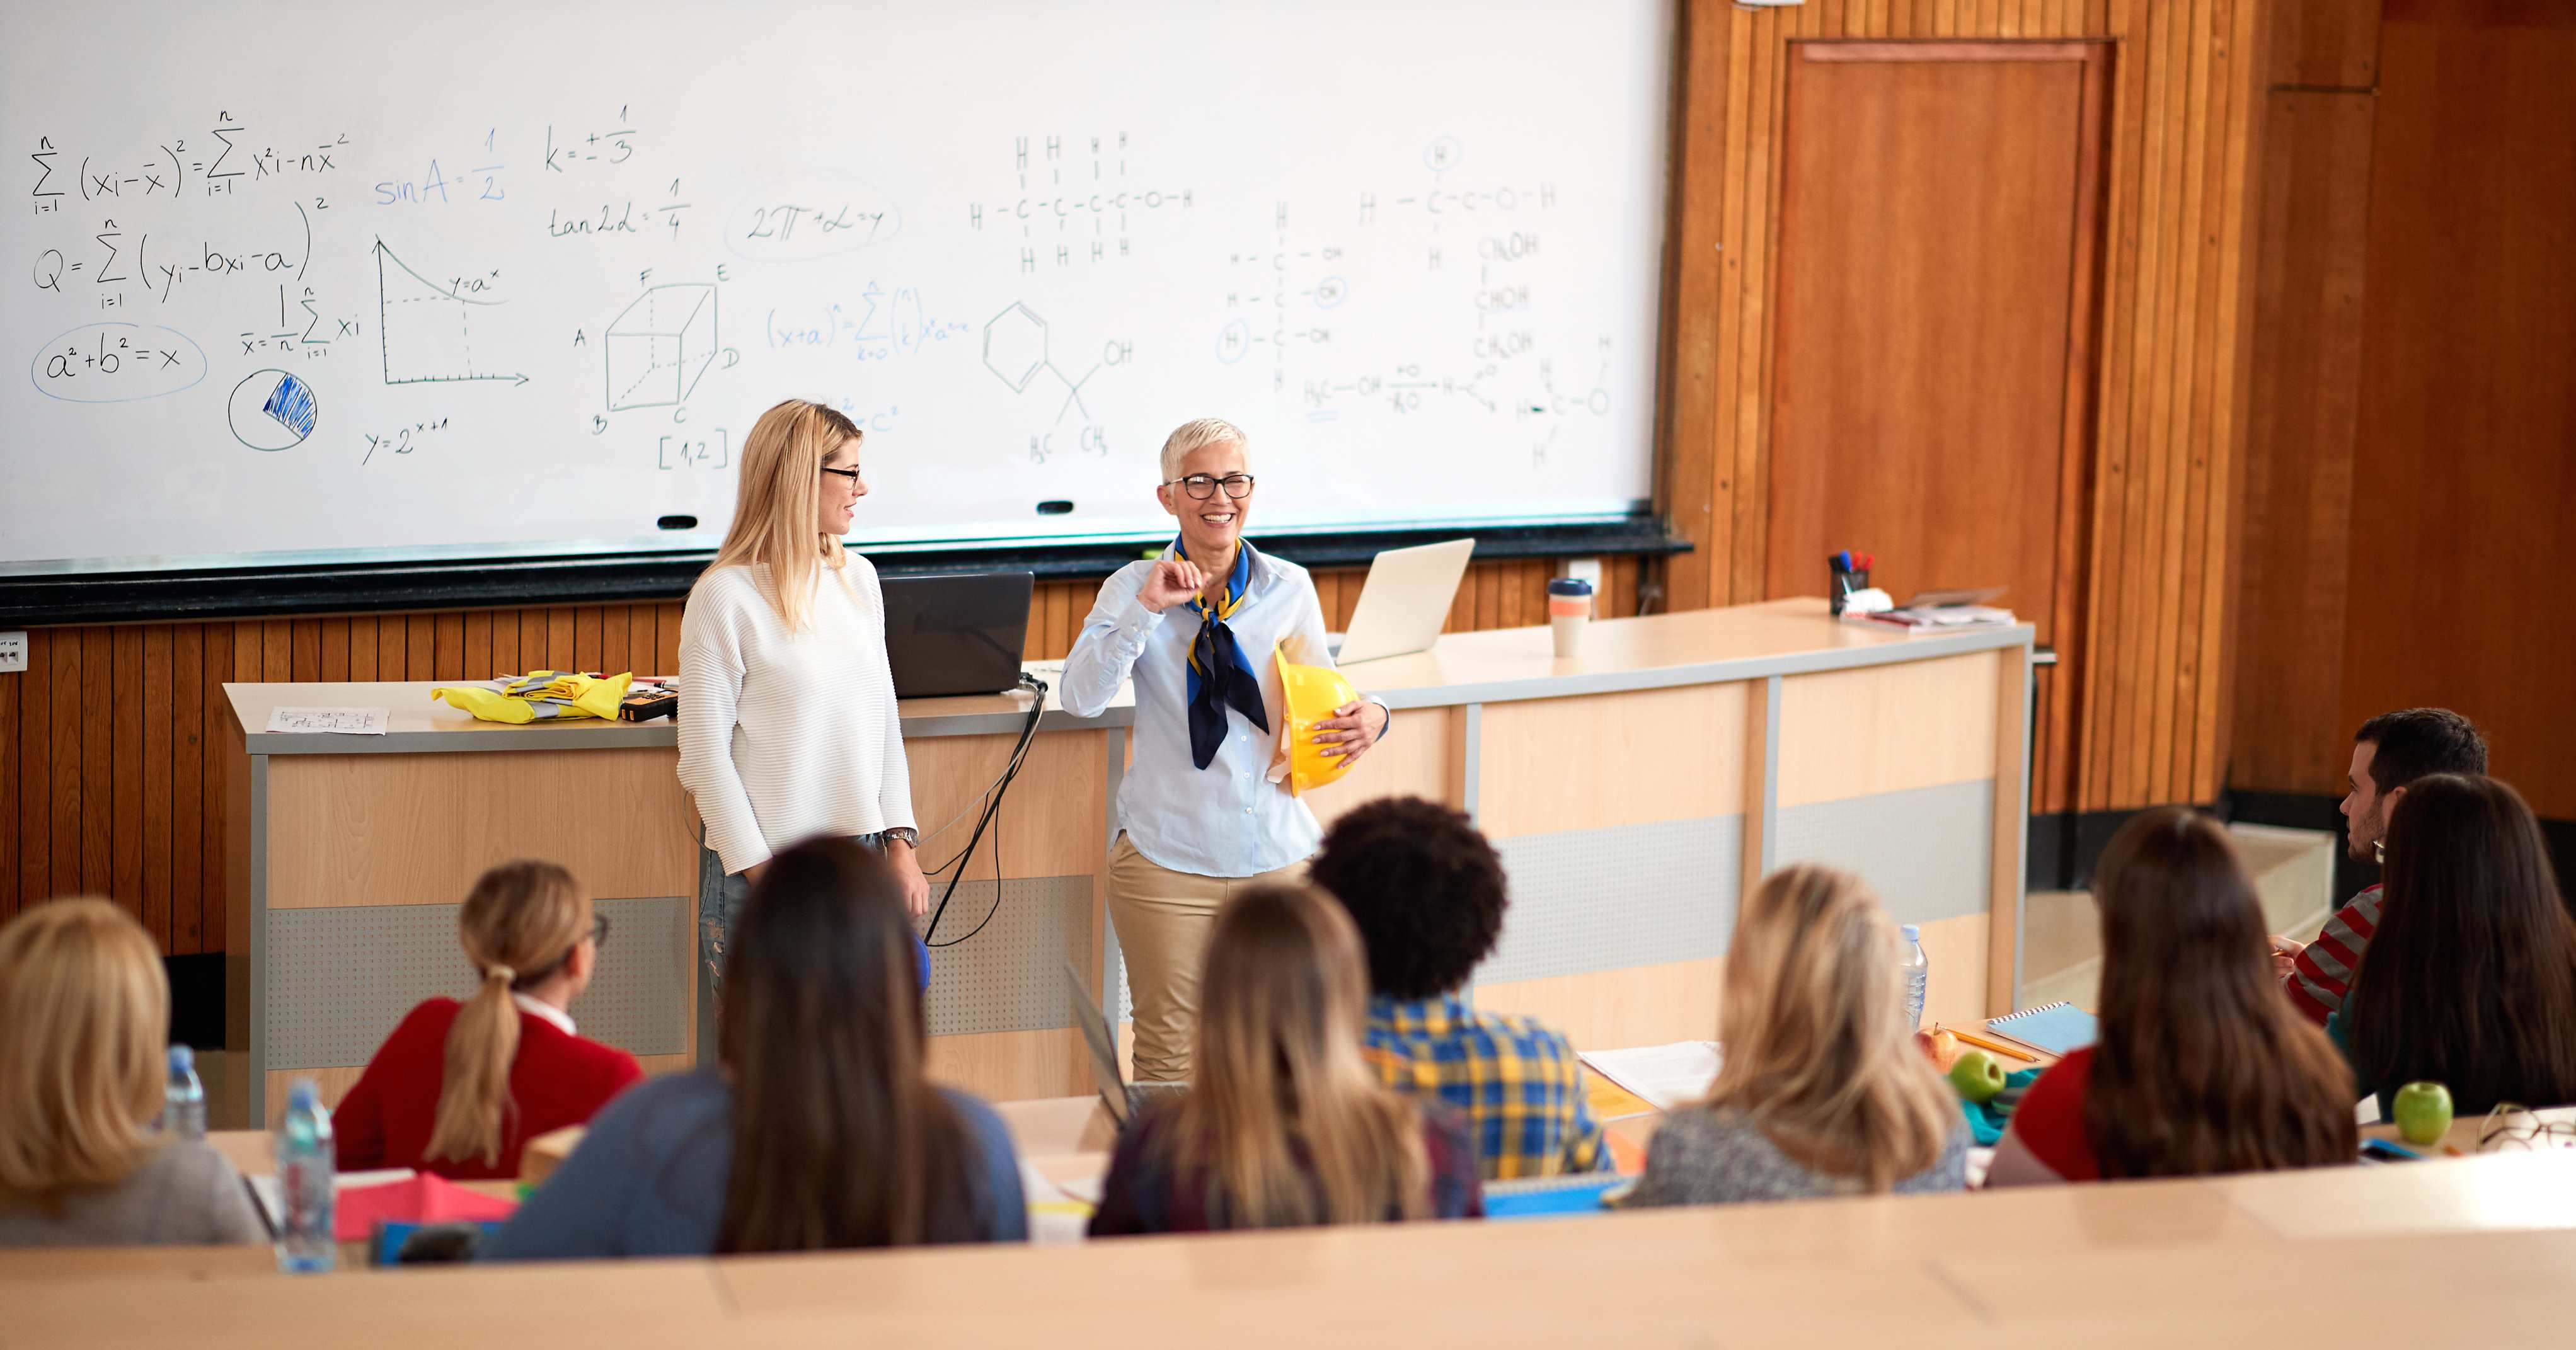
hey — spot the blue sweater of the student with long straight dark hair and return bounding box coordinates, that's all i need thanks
[479,1069,1028,1260]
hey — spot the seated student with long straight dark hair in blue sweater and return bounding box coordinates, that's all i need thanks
[481,840,1028,1260]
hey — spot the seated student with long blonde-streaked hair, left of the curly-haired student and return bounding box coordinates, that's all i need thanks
[1092,884,1484,1237]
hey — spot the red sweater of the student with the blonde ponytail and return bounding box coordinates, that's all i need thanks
[332,1000,644,1180]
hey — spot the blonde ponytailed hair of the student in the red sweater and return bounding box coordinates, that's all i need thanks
[425,861,590,1167]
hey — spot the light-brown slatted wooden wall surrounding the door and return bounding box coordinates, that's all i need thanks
[1659,0,2267,811]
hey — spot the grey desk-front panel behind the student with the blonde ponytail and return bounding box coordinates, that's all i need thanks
[265,896,696,1069]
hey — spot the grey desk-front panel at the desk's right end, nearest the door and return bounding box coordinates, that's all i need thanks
[1780,778,1994,922]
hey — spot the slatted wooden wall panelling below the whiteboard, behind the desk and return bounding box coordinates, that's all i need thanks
[0,559,1607,956]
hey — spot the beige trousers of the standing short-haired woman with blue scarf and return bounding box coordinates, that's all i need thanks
[1110,832,1306,1082]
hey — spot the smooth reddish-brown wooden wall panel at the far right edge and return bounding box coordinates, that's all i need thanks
[2342,0,2576,816]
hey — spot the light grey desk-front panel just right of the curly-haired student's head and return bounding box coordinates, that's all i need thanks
[1476,816,1744,984]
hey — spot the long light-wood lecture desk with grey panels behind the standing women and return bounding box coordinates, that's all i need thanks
[224,600,2030,1121]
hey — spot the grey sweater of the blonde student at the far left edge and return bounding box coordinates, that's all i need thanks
[0,1139,268,1247]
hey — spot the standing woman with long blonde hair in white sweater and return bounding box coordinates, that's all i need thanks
[680,399,930,1059]
